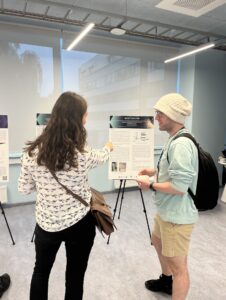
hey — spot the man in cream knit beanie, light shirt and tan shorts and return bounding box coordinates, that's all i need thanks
[137,93,198,300]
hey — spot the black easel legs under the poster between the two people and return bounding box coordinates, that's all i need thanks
[107,179,151,244]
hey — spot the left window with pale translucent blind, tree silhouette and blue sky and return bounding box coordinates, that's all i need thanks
[0,40,55,153]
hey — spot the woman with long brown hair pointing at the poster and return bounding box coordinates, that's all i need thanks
[18,92,113,300]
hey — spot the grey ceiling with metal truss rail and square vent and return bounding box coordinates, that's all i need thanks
[0,0,226,51]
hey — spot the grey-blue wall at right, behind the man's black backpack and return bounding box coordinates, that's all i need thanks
[181,50,226,178]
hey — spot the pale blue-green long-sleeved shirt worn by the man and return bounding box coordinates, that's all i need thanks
[154,129,198,224]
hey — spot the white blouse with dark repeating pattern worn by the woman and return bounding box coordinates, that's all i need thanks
[18,147,110,232]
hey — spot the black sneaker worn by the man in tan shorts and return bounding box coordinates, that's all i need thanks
[145,275,173,295]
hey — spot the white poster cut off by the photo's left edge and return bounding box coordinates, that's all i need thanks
[0,115,9,182]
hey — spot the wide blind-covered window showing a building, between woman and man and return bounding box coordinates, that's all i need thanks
[62,51,176,146]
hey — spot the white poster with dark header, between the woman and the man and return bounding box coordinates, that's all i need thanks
[108,116,154,180]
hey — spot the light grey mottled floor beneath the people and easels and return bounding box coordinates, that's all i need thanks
[0,190,226,300]
